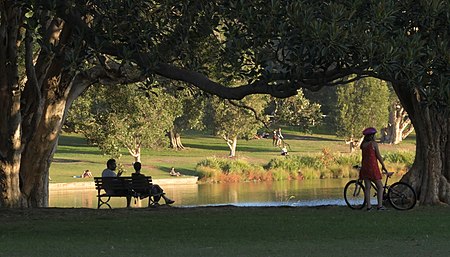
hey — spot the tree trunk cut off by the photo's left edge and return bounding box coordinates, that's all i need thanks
[0,5,22,207]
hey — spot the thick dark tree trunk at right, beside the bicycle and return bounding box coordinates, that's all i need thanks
[394,83,450,205]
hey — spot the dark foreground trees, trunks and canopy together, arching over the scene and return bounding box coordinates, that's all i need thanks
[0,0,450,207]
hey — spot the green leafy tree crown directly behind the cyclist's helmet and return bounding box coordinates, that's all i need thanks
[336,77,390,140]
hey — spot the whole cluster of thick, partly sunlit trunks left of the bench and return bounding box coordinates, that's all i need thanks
[0,6,132,208]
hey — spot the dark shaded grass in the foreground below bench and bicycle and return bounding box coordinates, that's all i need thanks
[0,206,450,257]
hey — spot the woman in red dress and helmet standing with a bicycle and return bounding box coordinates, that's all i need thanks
[359,128,390,211]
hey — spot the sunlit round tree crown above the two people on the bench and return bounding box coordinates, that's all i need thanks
[67,85,181,158]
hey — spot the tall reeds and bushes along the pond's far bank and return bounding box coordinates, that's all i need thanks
[196,149,414,183]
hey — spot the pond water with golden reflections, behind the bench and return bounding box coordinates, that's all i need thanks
[49,179,349,208]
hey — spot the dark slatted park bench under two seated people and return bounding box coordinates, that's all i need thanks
[94,176,157,209]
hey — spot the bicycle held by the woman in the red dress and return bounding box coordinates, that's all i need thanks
[344,166,417,210]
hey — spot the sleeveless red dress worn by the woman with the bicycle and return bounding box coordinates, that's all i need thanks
[359,142,381,180]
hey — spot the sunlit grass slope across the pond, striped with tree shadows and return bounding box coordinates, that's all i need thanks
[50,130,415,183]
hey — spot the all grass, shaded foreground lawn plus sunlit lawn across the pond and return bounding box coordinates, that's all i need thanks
[9,131,442,257]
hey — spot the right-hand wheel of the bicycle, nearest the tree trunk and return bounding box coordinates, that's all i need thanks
[388,182,417,210]
